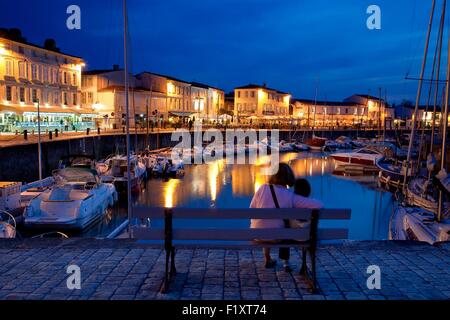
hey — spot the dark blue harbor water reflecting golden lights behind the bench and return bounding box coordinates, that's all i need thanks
[21,153,392,240]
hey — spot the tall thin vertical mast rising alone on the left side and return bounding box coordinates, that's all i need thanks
[123,0,132,238]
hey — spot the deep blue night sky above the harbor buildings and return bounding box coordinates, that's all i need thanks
[0,0,445,102]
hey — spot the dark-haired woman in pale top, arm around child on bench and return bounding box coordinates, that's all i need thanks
[250,163,323,272]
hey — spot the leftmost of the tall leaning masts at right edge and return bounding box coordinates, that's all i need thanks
[403,0,436,193]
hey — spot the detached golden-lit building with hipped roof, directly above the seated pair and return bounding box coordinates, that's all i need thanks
[234,84,291,123]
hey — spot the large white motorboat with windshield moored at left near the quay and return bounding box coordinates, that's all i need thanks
[24,167,117,230]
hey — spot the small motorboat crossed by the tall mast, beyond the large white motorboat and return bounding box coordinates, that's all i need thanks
[97,154,147,193]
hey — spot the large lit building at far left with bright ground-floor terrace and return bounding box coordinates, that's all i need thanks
[0,38,95,133]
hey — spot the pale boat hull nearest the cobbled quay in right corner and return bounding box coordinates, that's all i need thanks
[389,205,450,245]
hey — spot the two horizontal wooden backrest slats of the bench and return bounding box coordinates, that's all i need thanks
[132,207,351,241]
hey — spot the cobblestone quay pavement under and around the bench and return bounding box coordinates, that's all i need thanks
[0,239,450,300]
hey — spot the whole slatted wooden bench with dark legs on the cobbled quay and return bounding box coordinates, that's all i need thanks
[131,207,351,293]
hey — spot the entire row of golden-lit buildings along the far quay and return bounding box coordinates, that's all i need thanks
[0,30,442,132]
